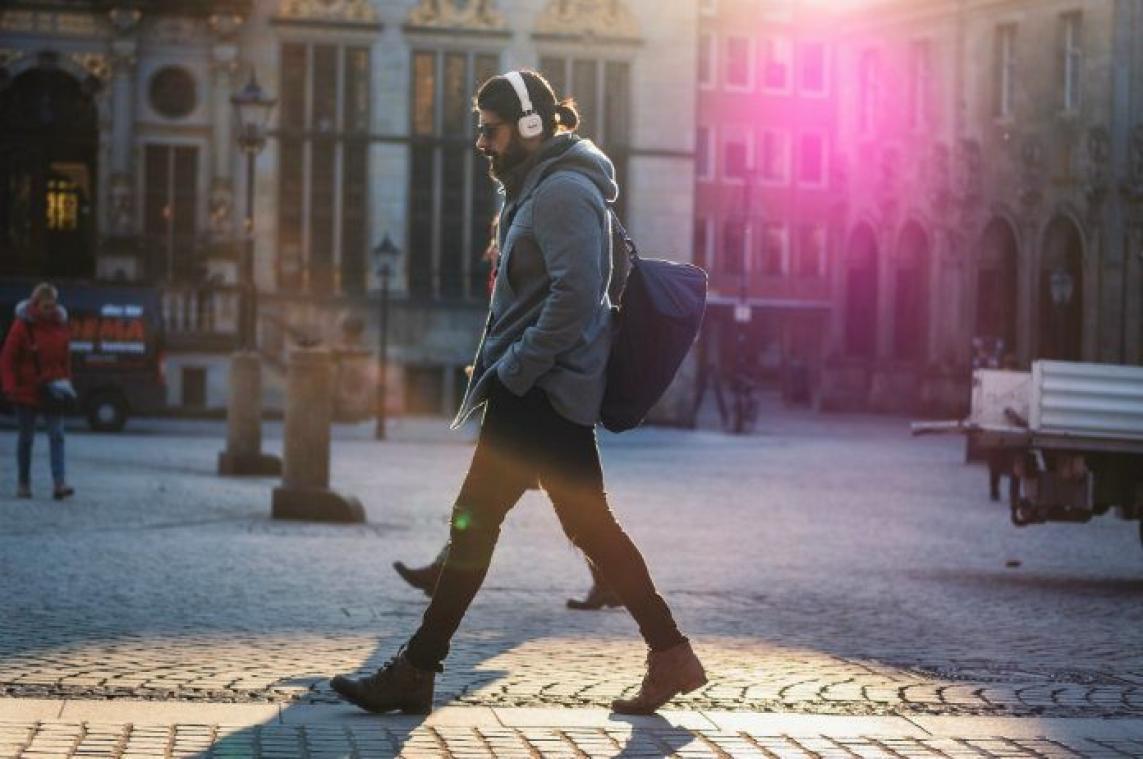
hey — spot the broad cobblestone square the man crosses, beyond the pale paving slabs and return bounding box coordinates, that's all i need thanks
[0,406,1143,726]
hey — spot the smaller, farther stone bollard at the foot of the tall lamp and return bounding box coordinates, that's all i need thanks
[218,352,282,477]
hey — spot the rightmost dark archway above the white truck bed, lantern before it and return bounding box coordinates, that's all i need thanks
[1038,216,1084,361]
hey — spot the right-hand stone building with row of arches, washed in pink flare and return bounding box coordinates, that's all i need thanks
[821,0,1143,412]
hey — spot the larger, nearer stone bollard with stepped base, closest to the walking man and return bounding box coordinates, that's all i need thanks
[271,349,365,522]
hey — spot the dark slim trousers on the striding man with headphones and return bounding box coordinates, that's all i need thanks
[405,383,686,670]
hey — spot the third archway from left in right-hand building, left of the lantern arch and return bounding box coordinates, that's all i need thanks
[974,218,1020,353]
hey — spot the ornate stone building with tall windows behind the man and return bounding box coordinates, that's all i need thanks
[0,0,697,416]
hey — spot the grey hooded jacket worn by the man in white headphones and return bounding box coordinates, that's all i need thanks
[453,135,620,429]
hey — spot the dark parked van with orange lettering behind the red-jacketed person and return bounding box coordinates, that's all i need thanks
[0,280,167,432]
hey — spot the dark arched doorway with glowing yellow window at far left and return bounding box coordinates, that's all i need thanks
[0,66,98,278]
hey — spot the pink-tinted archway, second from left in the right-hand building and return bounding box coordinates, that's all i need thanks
[893,222,929,361]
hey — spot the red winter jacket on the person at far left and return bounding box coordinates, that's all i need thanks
[0,301,71,406]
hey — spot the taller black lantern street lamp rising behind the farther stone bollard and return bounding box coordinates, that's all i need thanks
[230,72,278,351]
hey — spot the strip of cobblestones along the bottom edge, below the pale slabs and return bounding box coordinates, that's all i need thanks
[0,722,1143,759]
